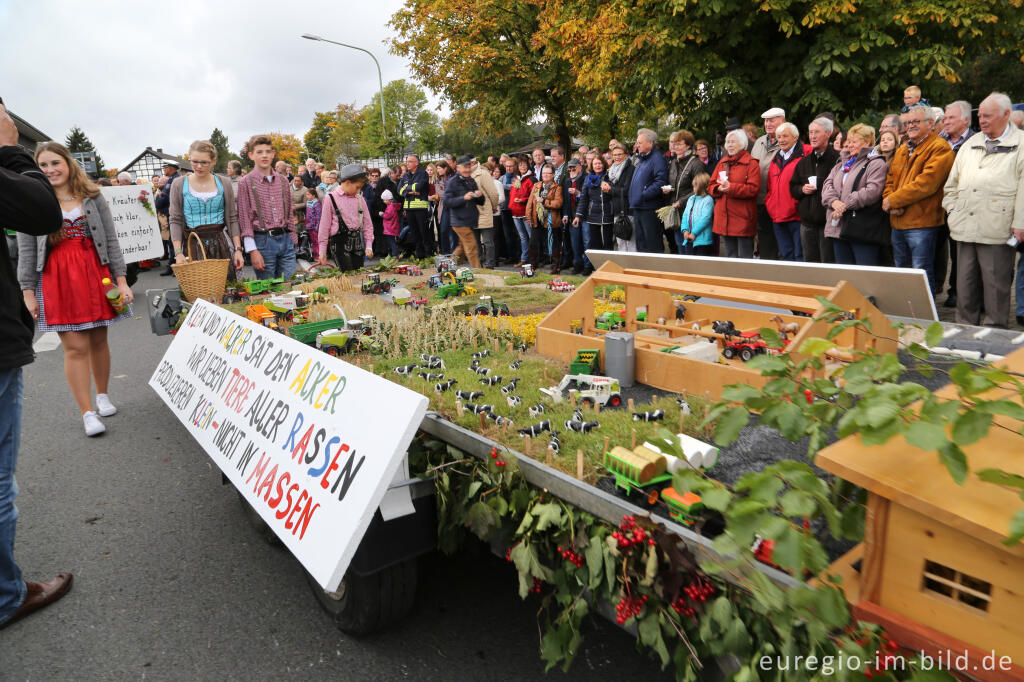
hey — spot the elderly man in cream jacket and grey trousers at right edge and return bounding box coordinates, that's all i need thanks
[942,92,1024,328]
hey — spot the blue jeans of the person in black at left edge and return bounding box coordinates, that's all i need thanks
[0,368,27,623]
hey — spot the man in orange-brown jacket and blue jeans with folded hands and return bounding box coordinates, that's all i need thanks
[882,105,956,294]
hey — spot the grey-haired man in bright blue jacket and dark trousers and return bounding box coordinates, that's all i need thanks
[629,128,669,253]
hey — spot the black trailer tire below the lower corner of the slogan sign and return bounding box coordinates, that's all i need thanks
[306,558,417,637]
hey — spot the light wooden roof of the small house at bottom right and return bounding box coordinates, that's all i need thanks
[815,349,1024,557]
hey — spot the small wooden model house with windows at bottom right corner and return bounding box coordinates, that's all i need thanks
[815,350,1024,680]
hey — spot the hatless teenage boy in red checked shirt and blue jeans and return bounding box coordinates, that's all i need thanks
[238,135,297,280]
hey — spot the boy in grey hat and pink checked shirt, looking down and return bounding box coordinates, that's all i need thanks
[316,163,374,272]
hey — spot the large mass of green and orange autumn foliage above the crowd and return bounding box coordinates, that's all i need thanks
[390,0,1024,143]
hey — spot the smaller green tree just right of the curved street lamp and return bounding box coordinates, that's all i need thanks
[359,79,441,158]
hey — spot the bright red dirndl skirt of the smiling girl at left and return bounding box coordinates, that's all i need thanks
[42,237,117,325]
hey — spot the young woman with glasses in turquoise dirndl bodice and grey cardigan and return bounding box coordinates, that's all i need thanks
[170,140,245,280]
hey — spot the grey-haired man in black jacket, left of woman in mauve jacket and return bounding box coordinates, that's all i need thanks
[790,117,839,263]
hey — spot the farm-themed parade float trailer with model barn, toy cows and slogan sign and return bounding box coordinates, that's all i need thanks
[147,251,1024,680]
